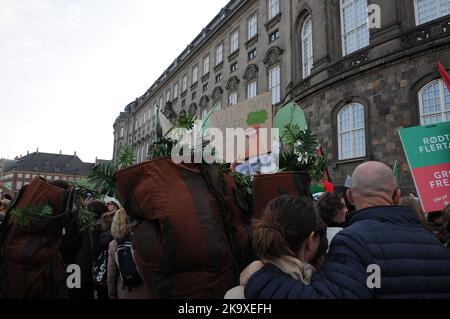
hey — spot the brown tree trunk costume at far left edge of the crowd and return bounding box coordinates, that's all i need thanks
[0,177,73,299]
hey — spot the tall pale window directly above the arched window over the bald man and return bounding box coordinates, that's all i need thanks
[341,0,369,56]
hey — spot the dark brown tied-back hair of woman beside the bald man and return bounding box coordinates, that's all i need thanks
[253,195,326,259]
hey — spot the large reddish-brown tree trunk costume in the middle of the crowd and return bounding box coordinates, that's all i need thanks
[116,158,247,299]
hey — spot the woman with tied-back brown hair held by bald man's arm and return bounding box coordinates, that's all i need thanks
[225,195,328,299]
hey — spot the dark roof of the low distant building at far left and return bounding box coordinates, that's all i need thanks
[4,152,94,176]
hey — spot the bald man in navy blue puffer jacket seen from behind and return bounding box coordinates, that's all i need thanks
[245,162,450,299]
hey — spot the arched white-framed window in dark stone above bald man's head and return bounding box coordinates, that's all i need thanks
[337,103,366,160]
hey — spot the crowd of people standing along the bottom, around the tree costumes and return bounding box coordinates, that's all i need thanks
[0,162,450,299]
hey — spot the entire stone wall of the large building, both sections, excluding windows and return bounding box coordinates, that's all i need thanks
[115,0,450,195]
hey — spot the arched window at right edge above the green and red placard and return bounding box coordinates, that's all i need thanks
[419,80,450,125]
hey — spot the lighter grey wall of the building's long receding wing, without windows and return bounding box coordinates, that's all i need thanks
[110,0,292,162]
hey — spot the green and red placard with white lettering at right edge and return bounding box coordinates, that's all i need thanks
[399,122,450,212]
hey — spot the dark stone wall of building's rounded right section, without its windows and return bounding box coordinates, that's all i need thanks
[291,0,450,192]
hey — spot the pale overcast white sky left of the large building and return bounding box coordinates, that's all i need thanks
[0,0,228,162]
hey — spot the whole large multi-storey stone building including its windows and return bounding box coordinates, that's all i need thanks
[114,0,450,192]
